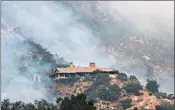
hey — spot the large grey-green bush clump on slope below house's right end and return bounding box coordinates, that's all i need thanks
[84,73,121,100]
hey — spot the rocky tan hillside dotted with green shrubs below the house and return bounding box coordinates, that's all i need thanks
[53,73,174,110]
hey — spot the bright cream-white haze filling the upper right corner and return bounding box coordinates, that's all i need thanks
[97,1,174,42]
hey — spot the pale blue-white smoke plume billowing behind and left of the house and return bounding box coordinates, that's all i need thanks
[1,1,114,101]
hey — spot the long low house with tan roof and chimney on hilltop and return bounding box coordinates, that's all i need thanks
[51,63,118,79]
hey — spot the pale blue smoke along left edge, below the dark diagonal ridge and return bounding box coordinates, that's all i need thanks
[1,31,51,101]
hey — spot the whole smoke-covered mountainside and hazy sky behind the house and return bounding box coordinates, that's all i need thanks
[1,1,174,102]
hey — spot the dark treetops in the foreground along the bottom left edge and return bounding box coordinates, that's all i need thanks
[1,94,96,110]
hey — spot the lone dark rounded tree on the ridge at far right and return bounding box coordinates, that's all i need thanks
[146,79,159,93]
